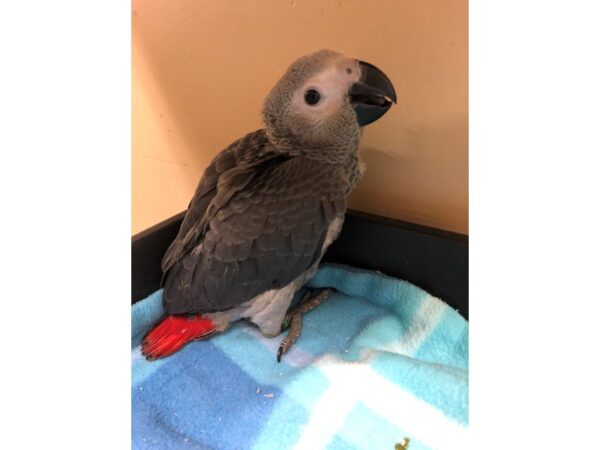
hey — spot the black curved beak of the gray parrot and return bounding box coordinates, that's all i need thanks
[348,61,397,127]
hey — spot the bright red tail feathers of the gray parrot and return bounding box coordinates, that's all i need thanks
[142,315,217,360]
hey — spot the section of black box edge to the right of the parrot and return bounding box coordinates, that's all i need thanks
[323,211,469,319]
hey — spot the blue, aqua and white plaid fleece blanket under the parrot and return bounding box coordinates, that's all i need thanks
[132,265,468,450]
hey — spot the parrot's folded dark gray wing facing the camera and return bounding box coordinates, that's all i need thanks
[163,147,346,314]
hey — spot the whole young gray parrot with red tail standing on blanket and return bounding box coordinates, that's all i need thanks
[141,50,397,361]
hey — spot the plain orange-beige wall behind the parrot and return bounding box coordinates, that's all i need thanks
[132,0,468,233]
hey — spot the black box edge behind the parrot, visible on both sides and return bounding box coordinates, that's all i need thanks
[131,210,469,319]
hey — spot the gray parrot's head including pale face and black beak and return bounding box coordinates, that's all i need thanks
[263,50,396,156]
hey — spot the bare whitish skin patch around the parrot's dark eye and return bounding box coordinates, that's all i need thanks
[290,57,360,122]
